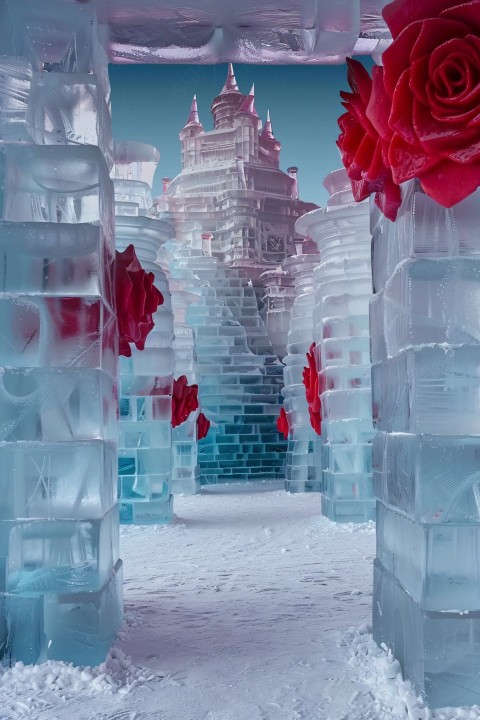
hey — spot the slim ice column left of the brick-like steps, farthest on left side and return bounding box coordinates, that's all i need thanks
[157,245,200,495]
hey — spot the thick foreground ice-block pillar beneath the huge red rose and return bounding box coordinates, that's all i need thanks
[370,181,480,707]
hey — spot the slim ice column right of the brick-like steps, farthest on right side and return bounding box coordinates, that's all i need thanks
[282,239,322,492]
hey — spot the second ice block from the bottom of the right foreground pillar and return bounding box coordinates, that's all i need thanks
[377,501,480,611]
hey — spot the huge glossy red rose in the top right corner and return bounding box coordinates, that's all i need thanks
[376,0,480,207]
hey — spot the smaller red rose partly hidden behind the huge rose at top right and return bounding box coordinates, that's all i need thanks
[337,59,401,220]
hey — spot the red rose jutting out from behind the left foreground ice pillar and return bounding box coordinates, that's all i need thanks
[115,245,163,357]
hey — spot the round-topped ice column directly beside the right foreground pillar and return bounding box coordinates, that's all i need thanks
[301,169,375,522]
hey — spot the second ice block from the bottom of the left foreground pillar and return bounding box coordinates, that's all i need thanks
[0,506,119,595]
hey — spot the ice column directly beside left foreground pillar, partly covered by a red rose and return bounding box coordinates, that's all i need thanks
[112,141,174,524]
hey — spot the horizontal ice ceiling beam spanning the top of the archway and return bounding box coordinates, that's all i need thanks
[104,0,389,64]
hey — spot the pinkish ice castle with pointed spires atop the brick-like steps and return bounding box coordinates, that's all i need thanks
[155,65,316,357]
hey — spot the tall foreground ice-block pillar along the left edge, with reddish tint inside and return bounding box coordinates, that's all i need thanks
[0,0,122,665]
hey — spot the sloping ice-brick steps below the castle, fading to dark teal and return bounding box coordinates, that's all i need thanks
[159,242,285,484]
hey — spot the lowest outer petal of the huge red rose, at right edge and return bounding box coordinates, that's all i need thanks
[420,156,480,208]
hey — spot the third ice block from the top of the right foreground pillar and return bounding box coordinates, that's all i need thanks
[372,346,480,435]
